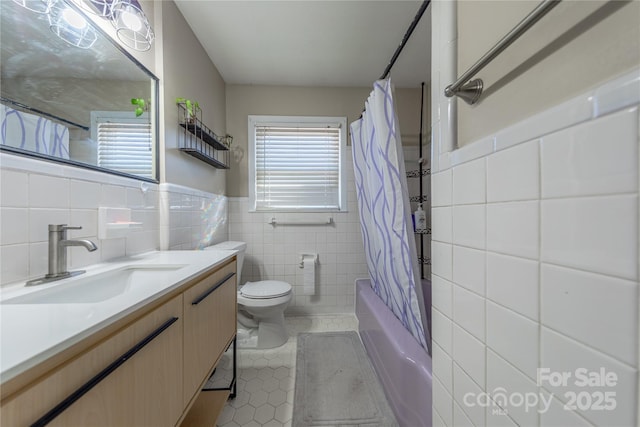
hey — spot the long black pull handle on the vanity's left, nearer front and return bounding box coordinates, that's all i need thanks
[31,317,178,427]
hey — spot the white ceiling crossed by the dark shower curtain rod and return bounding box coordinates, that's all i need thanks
[176,0,431,87]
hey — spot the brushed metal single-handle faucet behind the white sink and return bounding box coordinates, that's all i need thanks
[27,224,98,286]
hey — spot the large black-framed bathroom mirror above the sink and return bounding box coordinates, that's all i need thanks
[0,0,158,182]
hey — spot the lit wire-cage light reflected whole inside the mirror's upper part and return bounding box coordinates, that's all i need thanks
[48,0,98,49]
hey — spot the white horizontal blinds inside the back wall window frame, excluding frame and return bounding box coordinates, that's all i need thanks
[255,125,340,211]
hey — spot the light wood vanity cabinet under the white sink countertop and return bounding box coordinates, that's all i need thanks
[0,258,236,427]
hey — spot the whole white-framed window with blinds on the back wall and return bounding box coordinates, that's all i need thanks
[249,116,347,212]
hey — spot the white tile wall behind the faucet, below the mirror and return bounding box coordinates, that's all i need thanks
[0,153,159,285]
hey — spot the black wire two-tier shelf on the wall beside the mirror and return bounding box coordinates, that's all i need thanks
[178,103,230,169]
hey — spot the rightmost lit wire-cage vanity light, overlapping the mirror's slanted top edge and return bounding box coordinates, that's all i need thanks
[111,0,155,51]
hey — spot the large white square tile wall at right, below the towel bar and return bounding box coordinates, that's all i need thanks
[432,70,640,426]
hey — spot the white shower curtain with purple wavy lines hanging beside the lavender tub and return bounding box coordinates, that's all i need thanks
[351,80,431,351]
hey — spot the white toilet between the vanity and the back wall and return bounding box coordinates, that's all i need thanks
[205,241,292,348]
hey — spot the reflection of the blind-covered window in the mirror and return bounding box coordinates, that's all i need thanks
[91,111,155,179]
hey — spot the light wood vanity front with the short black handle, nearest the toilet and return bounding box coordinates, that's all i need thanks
[184,260,237,406]
